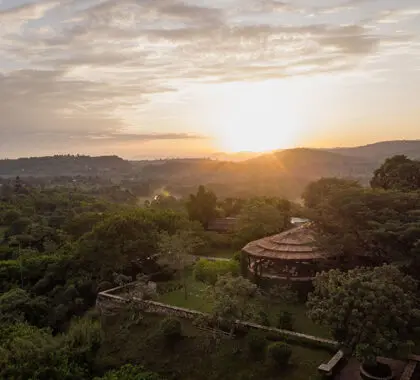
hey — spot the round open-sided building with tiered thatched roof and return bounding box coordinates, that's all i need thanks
[242,223,332,283]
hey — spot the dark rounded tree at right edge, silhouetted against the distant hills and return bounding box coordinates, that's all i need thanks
[370,155,420,191]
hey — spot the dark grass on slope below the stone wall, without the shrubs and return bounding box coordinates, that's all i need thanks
[96,314,331,380]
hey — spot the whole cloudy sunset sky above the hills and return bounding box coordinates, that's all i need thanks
[0,0,420,158]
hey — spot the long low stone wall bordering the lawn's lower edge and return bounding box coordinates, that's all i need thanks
[96,284,339,350]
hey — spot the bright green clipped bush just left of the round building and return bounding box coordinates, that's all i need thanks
[194,259,239,285]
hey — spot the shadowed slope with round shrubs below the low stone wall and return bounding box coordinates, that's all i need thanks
[97,313,331,380]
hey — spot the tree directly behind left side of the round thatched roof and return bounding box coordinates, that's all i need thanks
[235,198,290,247]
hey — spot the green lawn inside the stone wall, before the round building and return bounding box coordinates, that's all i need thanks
[159,275,330,338]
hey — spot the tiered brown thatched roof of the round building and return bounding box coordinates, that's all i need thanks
[243,223,329,260]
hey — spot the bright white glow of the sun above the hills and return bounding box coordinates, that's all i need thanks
[212,81,301,152]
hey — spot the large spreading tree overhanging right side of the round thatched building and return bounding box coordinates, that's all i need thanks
[311,188,420,267]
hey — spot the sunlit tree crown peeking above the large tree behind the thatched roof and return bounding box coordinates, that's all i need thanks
[302,177,361,208]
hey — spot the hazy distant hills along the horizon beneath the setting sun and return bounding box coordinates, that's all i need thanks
[0,140,420,185]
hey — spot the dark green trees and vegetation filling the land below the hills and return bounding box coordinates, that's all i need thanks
[0,155,420,380]
